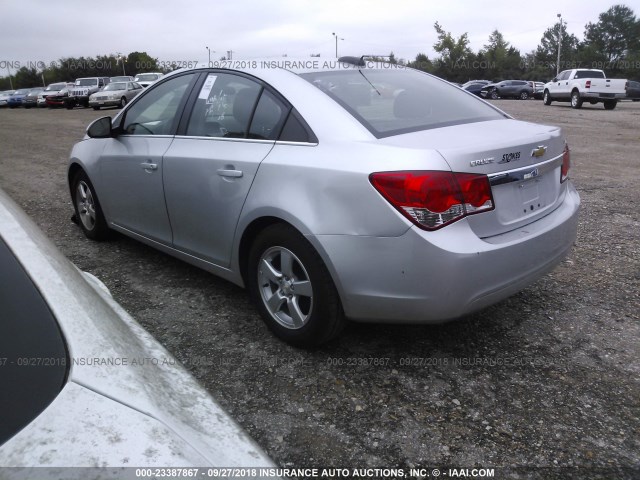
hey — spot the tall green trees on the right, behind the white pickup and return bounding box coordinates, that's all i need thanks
[399,5,640,82]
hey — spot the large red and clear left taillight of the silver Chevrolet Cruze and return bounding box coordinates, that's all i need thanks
[369,171,494,230]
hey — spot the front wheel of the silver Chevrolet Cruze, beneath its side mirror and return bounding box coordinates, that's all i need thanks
[71,170,109,240]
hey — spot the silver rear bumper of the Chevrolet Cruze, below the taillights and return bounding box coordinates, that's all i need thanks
[309,183,580,323]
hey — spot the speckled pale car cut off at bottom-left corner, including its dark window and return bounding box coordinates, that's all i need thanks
[0,190,273,468]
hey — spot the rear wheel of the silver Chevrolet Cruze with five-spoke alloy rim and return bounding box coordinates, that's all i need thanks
[247,224,345,347]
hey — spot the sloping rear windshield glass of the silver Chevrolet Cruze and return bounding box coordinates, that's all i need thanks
[300,68,504,138]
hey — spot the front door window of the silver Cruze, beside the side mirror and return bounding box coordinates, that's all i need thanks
[121,74,194,135]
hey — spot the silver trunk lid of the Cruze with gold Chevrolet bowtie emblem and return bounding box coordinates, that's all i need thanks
[382,119,565,237]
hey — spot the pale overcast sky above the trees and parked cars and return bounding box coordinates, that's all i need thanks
[0,0,640,76]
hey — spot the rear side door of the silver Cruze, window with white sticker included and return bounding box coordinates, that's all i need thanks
[164,71,288,267]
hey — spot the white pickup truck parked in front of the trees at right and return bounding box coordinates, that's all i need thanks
[543,68,627,110]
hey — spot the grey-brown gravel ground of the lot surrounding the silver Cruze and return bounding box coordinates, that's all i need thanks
[0,100,640,479]
